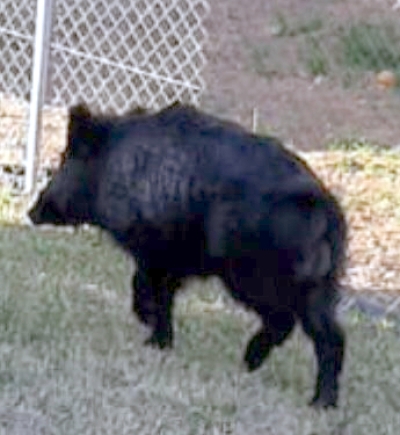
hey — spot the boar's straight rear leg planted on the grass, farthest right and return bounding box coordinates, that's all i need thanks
[299,284,345,408]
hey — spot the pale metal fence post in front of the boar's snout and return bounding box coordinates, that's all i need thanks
[25,0,53,194]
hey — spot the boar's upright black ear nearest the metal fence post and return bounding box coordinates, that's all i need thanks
[67,103,105,158]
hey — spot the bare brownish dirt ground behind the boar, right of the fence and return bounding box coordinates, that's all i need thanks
[203,0,400,150]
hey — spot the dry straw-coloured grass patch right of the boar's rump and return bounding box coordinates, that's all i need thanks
[305,147,400,291]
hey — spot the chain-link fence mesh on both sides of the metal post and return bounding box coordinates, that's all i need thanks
[0,0,208,188]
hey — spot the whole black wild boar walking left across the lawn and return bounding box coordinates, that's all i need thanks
[29,104,347,407]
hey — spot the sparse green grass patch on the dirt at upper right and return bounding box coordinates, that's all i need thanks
[252,11,400,87]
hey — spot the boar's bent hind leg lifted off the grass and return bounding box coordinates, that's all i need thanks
[244,311,295,371]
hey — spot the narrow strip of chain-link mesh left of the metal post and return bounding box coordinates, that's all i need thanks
[0,0,36,189]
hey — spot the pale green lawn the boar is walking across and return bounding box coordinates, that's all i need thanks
[0,227,400,435]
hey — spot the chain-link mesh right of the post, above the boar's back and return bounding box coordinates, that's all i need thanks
[47,0,207,113]
